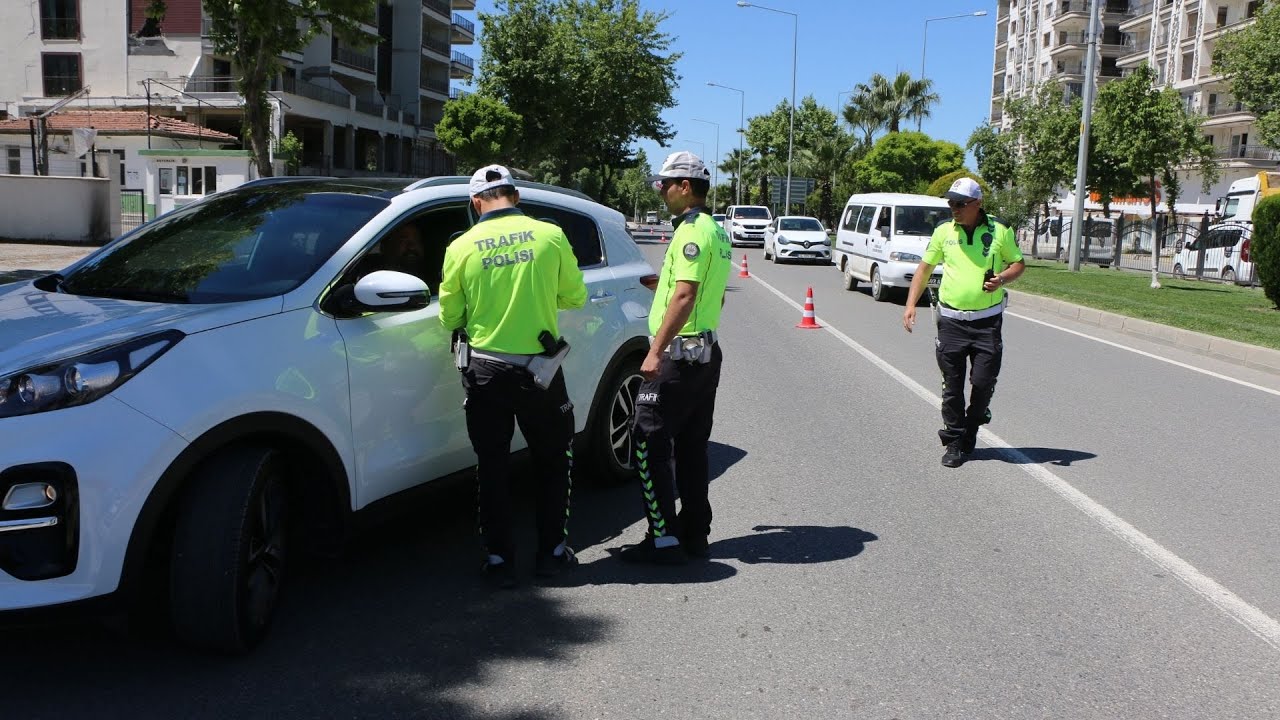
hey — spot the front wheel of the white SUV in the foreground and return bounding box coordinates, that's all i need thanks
[169,446,289,653]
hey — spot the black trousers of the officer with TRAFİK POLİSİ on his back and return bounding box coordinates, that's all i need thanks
[462,357,573,560]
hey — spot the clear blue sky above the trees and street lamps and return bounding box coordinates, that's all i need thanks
[462,0,996,175]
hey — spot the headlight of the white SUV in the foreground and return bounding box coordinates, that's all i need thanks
[0,331,186,418]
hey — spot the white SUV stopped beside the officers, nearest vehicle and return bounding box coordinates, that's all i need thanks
[0,178,657,651]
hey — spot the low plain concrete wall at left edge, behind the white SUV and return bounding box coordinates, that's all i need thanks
[0,176,120,243]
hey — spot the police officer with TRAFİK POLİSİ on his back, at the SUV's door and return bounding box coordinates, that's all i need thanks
[440,165,586,588]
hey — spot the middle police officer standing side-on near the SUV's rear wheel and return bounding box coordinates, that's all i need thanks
[621,152,732,565]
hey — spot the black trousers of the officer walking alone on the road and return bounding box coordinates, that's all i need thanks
[936,313,1005,451]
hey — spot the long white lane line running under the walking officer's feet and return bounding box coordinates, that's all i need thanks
[753,266,1280,651]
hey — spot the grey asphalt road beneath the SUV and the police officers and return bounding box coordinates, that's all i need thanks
[0,245,1280,720]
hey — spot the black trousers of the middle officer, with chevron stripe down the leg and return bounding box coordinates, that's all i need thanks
[632,343,724,539]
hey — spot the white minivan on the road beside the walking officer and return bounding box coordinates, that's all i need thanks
[831,192,951,301]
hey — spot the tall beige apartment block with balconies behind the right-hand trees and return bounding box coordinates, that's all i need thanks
[991,0,1280,204]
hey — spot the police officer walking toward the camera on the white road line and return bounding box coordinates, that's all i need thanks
[902,178,1027,468]
